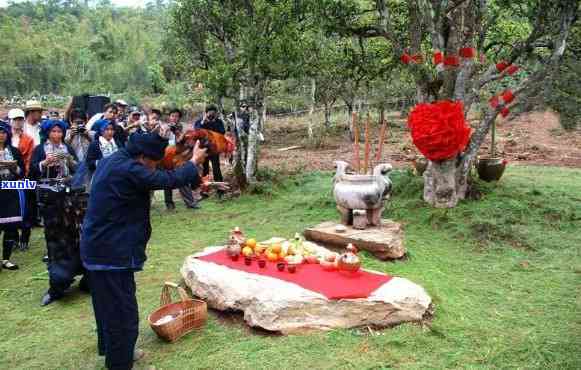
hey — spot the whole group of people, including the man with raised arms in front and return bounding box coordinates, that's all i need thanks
[0,100,249,369]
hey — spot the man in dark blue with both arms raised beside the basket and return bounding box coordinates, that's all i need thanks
[81,133,206,369]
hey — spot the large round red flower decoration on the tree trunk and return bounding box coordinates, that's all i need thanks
[408,101,471,161]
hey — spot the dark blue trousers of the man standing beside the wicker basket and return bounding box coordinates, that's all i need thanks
[88,270,139,370]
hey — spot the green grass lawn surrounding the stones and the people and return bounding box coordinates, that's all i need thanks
[0,167,581,369]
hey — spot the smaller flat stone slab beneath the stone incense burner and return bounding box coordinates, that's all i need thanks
[304,219,406,260]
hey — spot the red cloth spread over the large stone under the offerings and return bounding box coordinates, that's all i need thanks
[198,249,391,299]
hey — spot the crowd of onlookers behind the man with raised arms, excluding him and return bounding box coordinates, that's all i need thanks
[0,100,249,278]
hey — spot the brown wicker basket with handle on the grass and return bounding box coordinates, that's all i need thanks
[147,282,208,342]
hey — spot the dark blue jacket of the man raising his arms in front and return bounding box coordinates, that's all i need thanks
[81,149,200,269]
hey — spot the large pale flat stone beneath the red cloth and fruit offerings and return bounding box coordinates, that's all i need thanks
[181,247,431,334]
